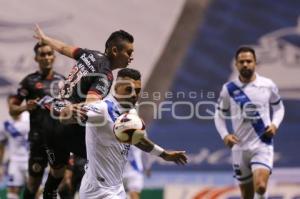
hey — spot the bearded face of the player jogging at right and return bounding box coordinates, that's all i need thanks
[235,52,256,79]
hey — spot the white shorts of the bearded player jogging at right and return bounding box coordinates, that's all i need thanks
[232,145,274,184]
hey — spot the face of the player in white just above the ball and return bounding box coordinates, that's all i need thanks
[115,77,141,108]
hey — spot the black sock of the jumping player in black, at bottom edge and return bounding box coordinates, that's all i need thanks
[43,173,63,199]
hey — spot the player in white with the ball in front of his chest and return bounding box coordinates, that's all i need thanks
[80,68,187,199]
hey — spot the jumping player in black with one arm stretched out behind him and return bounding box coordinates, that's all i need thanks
[34,26,134,199]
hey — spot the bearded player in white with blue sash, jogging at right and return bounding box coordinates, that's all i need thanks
[215,47,284,199]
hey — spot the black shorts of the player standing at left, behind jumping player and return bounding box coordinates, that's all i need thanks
[28,129,48,177]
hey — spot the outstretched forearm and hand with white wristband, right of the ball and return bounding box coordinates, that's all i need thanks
[135,137,187,165]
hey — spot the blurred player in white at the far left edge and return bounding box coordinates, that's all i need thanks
[0,95,29,199]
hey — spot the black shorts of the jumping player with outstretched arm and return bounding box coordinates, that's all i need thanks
[43,112,86,168]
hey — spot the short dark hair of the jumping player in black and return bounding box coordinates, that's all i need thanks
[105,30,134,50]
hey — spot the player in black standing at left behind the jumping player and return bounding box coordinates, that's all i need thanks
[9,43,64,199]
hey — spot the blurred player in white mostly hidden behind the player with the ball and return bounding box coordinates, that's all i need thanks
[123,146,144,199]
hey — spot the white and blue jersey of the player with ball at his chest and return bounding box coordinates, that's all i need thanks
[82,95,130,187]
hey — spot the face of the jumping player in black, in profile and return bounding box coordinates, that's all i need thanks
[114,41,133,68]
